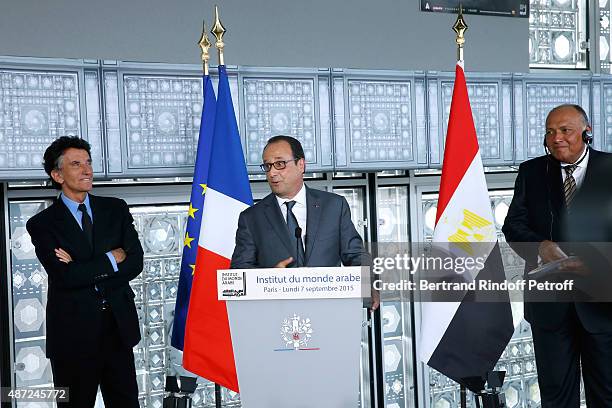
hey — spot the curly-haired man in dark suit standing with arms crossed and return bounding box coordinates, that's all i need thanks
[27,136,143,408]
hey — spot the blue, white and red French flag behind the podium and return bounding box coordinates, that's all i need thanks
[183,65,253,392]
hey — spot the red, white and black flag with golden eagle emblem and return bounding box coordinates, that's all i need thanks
[419,61,514,391]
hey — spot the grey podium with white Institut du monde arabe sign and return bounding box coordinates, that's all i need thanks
[217,267,369,408]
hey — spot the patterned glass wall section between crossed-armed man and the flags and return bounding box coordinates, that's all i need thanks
[131,205,240,408]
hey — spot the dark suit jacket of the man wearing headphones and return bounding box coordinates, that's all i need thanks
[502,149,612,333]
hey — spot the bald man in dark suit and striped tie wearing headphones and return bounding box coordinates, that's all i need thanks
[503,105,612,408]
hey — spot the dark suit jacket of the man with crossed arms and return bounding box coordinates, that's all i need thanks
[26,194,143,358]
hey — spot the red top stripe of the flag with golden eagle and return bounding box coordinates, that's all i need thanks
[436,63,478,224]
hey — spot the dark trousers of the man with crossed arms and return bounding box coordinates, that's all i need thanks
[51,310,139,408]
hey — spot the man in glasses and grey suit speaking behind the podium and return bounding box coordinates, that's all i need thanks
[231,135,377,307]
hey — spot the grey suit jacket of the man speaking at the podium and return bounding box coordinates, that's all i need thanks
[231,187,368,269]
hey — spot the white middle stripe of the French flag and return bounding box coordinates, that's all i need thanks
[198,187,249,259]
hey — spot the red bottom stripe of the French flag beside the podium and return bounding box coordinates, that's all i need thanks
[183,247,239,392]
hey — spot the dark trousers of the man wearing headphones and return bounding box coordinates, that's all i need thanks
[531,307,612,408]
